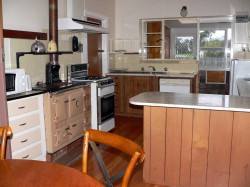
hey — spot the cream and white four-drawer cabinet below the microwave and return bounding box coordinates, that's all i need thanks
[7,94,46,161]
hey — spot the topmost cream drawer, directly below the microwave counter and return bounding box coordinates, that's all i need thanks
[8,97,38,117]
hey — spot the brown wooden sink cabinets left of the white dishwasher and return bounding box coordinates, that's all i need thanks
[111,75,159,116]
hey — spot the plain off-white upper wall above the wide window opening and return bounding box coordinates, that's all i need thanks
[115,0,250,39]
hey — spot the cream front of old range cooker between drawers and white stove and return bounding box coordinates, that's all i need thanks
[44,85,91,154]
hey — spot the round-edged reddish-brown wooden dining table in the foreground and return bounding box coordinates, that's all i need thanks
[0,159,104,187]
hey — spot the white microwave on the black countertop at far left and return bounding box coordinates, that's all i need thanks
[5,69,27,95]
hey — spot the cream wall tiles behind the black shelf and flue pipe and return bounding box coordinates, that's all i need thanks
[4,33,87,86]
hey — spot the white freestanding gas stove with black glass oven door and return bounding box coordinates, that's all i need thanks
[68,64,115,131]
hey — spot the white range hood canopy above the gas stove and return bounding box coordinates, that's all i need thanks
[58,18,109,34]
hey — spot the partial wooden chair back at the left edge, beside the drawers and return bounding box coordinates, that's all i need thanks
[0,126,12,160]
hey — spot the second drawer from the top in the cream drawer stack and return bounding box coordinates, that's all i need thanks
[9,113,40,134]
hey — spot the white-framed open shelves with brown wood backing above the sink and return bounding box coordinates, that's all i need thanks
[142,20,170,59]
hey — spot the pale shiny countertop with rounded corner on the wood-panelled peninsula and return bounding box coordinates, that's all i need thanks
[129,92,250,112]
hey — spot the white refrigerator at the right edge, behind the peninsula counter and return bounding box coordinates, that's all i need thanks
[229,60,250,95]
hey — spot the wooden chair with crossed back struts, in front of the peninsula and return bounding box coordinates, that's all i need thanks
[82,129,145,187]
